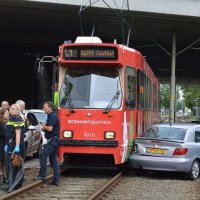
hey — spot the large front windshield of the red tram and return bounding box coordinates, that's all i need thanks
[59,68,122,109]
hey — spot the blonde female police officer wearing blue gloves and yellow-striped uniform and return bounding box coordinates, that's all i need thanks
[4,104,25,189]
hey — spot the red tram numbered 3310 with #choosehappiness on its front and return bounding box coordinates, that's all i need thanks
[58,37,159,165]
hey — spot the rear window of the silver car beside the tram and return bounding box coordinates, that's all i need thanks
[142,126,186,140]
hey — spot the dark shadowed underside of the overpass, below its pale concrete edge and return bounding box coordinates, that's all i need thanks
[0,0,200,104]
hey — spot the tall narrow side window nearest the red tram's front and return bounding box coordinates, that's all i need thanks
[125,67,136,109]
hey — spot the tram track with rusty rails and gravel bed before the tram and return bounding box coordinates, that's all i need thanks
[0,167,123,200]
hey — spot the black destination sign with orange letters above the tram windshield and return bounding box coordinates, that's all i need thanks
[63,46,118,60]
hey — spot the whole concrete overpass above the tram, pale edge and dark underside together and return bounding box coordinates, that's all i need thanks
[0,0,200,119]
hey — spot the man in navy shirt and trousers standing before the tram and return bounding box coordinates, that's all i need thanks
[34,101,60,186]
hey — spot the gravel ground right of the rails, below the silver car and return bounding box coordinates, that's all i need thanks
[102,171,200,200]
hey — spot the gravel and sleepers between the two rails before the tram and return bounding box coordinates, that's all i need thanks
[13,169,117,200]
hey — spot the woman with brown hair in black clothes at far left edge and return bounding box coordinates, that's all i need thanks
[0,108,9,183]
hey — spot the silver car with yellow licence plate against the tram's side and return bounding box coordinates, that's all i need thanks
[129,124,200,180]
